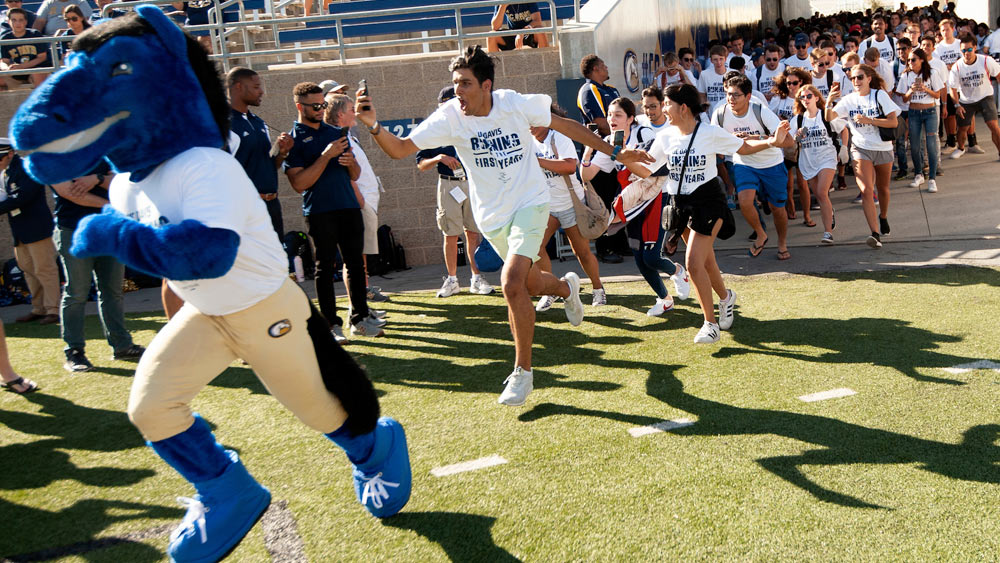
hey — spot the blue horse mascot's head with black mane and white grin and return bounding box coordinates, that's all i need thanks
[10,6,229,184]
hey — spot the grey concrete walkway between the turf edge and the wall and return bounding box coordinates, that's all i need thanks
[0,121,1000,326]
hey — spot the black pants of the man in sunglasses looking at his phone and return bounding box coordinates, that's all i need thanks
[306,209,368,325]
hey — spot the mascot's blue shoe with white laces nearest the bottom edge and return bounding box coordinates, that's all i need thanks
[167,451,271,563]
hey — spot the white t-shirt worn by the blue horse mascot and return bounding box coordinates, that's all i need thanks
[109,147,288,315]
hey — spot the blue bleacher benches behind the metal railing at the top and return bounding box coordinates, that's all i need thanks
[278,0,586,43]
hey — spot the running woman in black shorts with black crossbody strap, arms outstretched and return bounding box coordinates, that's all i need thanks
[614,84,788,343]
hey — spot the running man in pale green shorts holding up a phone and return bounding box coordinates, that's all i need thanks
[356,46,652,406]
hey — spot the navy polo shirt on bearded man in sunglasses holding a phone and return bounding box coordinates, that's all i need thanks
[284,121,361,216]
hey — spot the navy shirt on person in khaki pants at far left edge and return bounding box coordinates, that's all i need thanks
[0,156,52,246]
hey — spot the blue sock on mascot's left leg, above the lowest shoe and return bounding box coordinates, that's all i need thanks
[147,414,233,483]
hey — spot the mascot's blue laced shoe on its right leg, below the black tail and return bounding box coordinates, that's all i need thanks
[354,416,413,518]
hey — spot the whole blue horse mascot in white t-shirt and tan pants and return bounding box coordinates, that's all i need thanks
[10,6,412,561]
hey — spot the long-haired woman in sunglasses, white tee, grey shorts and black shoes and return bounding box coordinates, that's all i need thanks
[826,64,899,248]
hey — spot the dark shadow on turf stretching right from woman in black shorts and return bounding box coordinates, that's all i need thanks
[713,314,979,385]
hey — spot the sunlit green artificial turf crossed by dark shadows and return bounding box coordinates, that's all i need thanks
[0,268,1000,561]
